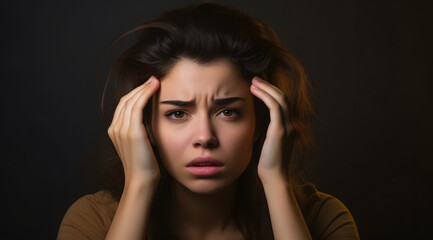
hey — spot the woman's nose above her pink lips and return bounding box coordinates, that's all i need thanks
[193,116,218,148]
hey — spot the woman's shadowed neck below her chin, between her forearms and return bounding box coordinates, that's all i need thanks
[170,181,237,235]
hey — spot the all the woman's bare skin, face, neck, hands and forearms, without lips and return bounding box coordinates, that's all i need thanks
[107,59,311,240]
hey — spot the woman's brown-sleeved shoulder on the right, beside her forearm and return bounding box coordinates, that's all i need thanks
[294,183,359,239]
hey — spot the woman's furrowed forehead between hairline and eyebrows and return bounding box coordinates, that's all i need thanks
[159,59,250,100]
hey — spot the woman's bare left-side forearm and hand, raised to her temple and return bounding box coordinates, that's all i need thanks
[105,78,160,240]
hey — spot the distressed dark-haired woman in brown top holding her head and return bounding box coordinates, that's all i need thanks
[58,2,359,239]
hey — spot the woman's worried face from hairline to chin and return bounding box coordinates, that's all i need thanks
[152,59,256,194]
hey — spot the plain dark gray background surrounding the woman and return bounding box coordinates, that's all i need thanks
[0,0,433,239]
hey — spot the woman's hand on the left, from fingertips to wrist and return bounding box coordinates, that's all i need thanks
[108,76,160,186]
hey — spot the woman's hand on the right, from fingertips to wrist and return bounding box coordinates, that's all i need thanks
[250,77,293,181]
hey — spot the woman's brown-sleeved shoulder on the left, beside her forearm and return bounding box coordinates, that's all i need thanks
[57,190,118,240]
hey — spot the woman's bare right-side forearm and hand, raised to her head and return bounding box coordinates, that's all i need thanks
[251,78,311,240]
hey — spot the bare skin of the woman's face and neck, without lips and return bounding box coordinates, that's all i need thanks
[152,59,256,239]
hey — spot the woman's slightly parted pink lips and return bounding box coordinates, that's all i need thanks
[186,157,224,176]
